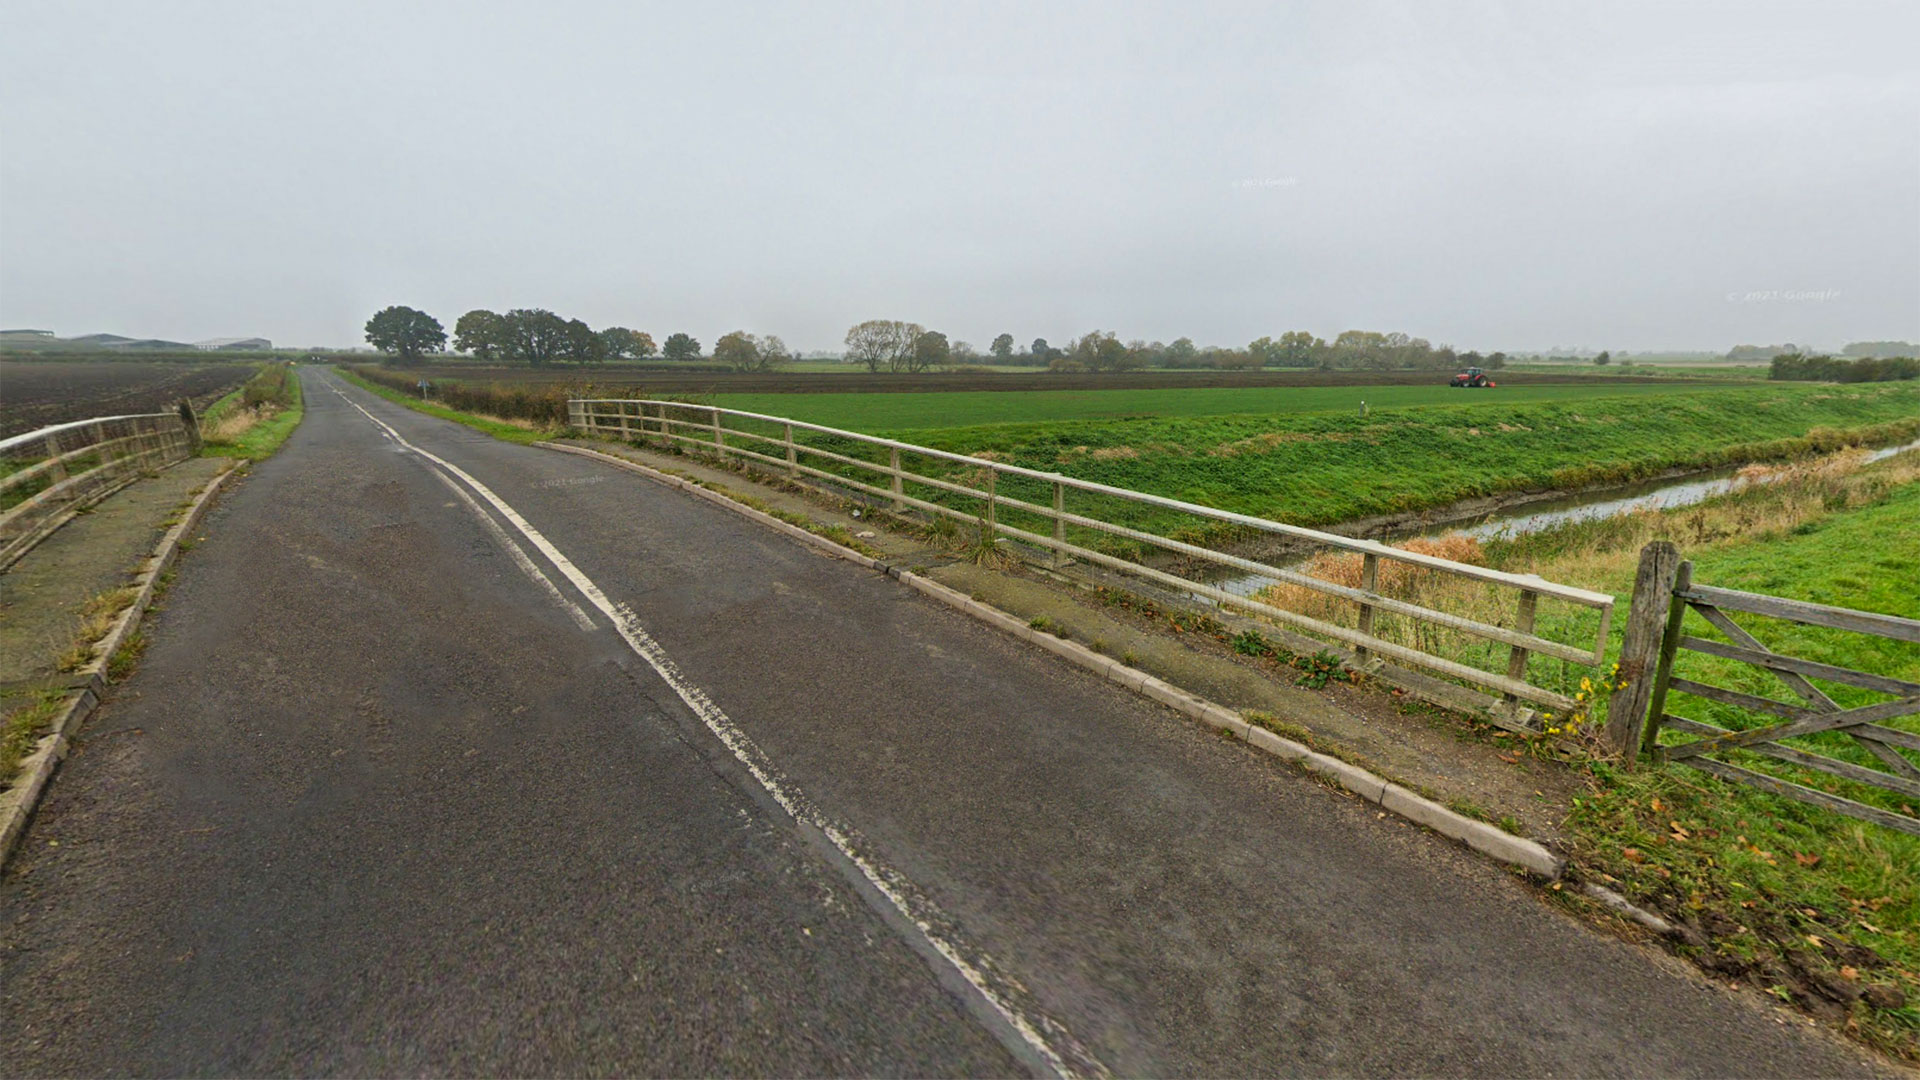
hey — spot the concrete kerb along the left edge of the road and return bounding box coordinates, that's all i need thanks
[0,461,234,867]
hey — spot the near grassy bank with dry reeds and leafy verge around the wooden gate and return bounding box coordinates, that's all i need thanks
[1420,454,1920,1057]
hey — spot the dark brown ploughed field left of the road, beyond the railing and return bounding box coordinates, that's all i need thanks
[0,359,253,438]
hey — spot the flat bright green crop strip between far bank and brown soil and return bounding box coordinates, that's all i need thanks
[714,380,1735,432]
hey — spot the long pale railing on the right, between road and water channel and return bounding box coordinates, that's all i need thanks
[568,398,1615,711]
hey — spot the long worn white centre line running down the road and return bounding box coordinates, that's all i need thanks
[334,376,1104,1076]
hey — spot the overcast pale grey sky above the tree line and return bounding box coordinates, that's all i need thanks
[0,0,1920,350]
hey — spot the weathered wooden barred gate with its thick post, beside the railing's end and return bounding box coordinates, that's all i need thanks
[1609,542,1920,836]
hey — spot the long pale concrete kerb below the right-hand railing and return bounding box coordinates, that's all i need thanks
[534,442,1567,878]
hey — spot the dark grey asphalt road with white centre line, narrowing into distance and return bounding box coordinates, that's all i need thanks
[0,367,1878,1076]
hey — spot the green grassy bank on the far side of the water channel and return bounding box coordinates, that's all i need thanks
[781,382,1920,525]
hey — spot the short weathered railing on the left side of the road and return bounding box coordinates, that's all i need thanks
[0,413,200,569]
